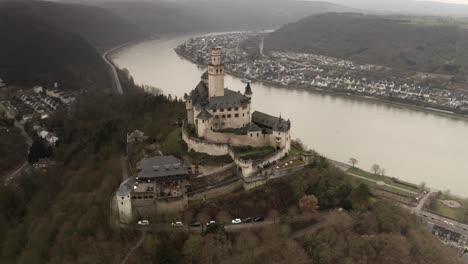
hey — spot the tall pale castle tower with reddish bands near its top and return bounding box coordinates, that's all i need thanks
[208,48,224,98]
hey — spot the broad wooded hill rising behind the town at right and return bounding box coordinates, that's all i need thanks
[265,13,468,74]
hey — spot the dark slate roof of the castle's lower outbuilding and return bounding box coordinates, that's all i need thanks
[137,156,188,179]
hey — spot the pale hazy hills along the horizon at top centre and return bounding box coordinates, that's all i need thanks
[81,0,352,35]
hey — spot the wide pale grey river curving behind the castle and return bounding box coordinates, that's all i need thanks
[112,36,468,196]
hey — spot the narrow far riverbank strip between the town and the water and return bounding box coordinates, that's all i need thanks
[174,48,468,121]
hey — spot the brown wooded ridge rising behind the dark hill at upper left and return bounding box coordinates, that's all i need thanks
[1,0,144,48]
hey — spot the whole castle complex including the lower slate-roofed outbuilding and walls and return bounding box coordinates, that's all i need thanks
[111,48,294,224]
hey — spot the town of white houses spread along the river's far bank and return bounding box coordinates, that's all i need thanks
[177,33,468,111]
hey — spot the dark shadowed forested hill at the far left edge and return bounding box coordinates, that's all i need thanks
[0,5,110,89]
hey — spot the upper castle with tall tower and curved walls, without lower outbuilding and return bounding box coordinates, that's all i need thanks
[183,48,291,177]
